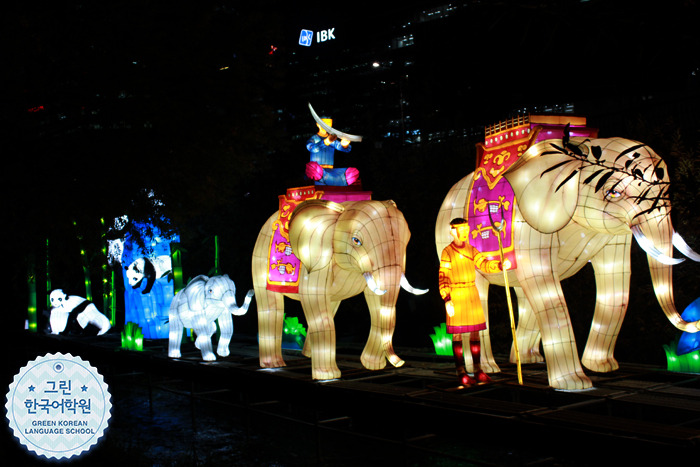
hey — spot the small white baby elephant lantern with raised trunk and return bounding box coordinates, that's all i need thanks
[168,274,253,361]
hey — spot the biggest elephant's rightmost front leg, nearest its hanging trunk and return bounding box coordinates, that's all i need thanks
[581,236,631,373]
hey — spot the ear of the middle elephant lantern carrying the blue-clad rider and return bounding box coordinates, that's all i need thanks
[289,199,345,271]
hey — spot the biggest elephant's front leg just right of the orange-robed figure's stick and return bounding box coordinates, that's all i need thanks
[514,227,593,390]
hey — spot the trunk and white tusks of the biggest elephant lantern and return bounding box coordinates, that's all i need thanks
[632,222,700,332]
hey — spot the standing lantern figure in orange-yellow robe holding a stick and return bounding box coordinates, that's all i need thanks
[440,218,491,386]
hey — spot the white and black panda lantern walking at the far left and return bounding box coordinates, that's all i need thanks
[49,289,111,336]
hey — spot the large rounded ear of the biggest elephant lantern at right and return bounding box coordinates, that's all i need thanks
[504,141,582,233]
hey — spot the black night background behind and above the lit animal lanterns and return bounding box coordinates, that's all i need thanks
[0,0,700,366]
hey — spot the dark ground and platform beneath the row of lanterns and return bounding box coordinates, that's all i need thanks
[0,334,700,467]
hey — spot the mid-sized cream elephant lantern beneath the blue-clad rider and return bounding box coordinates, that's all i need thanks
[253,200,427,379]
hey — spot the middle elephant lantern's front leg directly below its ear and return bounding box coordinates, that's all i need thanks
[299,288,340,380]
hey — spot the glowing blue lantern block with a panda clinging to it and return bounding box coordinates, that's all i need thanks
[110,223,180,339]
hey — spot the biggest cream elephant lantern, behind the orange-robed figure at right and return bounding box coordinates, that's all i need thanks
[436,119,698,390]
